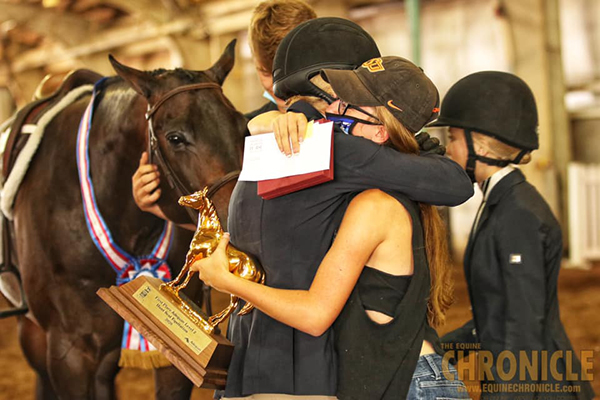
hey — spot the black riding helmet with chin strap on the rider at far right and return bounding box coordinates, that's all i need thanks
[429,71,539,181]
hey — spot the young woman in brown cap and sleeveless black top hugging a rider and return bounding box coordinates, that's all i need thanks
[192,57,469,399]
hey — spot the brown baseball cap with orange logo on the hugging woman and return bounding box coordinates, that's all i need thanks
[321,56,440,133]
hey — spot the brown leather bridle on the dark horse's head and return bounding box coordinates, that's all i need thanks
[146,82,240,223]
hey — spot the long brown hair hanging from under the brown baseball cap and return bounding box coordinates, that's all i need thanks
[376,106,453,327]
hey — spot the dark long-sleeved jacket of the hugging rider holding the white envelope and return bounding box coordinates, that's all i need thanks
[225,102,473,397]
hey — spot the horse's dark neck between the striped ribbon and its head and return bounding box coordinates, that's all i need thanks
[89,81,163,252]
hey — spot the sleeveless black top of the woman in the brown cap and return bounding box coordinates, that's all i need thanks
[335,192,437,400]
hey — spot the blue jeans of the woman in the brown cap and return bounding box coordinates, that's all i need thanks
[407,354,470,400]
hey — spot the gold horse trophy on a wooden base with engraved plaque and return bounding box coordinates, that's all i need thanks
[98,188,265,389]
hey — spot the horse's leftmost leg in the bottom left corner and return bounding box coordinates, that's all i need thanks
[19,317,58,400]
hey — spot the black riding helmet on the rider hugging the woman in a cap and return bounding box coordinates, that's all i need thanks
[273,17,381,103]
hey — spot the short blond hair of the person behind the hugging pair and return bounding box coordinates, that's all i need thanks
[248,0,317,71]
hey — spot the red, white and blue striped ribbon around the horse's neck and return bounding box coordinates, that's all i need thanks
[77,78,173,352]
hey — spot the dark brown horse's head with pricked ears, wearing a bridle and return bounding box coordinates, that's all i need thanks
[111,41,246,228]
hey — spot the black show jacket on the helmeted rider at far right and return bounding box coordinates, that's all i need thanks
[442,170,594,399]
